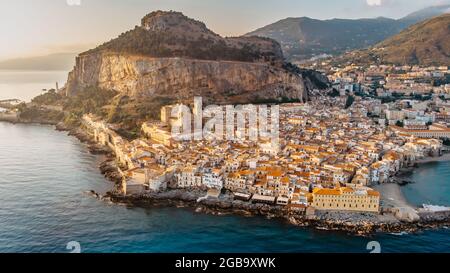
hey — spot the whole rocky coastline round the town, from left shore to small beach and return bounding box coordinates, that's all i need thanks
[3,122,450,236]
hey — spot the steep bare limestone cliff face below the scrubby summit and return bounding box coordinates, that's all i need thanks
[66,53,307,102]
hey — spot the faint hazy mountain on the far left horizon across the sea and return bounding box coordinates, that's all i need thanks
[0,53,77,71]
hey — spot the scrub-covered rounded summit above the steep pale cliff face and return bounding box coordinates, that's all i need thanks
[81,11,283,62]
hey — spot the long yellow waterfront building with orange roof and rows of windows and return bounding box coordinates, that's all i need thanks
[313,188,380,212]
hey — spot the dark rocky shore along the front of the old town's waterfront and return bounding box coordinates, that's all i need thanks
[110,190,450,235]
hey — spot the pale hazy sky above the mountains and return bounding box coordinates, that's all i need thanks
[0,0,450,60]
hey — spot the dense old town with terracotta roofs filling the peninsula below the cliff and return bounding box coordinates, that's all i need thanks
[83,92,444,215]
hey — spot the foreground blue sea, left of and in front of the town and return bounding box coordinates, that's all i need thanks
[0,123,450,253]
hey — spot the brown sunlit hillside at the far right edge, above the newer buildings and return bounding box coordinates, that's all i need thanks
[337,14,450,66]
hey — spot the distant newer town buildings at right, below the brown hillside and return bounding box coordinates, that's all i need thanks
[306,62,450,139]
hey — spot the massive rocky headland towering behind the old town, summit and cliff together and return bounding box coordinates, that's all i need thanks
[65,11,326,103]
